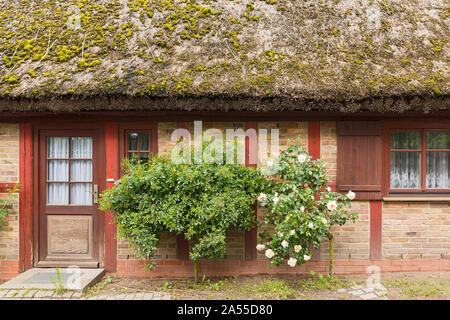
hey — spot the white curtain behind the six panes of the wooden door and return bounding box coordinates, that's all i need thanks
[47,137,92,205]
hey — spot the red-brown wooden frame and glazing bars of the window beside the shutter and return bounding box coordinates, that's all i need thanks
[386,127,450,195]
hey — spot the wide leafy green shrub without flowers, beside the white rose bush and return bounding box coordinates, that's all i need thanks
[101,156,266,280]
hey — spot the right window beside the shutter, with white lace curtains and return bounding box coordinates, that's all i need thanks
[390,130,450,193]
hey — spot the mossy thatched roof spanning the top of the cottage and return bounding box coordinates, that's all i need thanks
[0,0,450,111]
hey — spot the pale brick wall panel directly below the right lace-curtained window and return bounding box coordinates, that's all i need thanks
[382,202,450,260]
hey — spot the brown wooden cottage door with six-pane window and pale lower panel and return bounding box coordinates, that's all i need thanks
[38,130,101,268]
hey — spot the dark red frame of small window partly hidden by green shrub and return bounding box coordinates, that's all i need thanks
[119,121,158,176]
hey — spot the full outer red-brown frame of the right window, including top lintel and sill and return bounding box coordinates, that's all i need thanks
[383,126,450,196]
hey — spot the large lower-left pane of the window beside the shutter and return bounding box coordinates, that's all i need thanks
[391,152,420,189]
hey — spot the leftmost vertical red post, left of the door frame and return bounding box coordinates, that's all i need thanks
[19,123,33,272]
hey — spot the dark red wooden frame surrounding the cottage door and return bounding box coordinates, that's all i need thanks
[30,121,106,268]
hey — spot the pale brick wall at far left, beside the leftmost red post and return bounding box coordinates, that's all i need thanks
[0,124,19,280]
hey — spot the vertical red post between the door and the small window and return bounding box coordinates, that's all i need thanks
[105,123,119,272]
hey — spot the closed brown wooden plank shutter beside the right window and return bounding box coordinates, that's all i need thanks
[337,121,382,200]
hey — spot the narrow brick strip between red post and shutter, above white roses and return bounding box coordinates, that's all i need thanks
[320,121,337,182]
